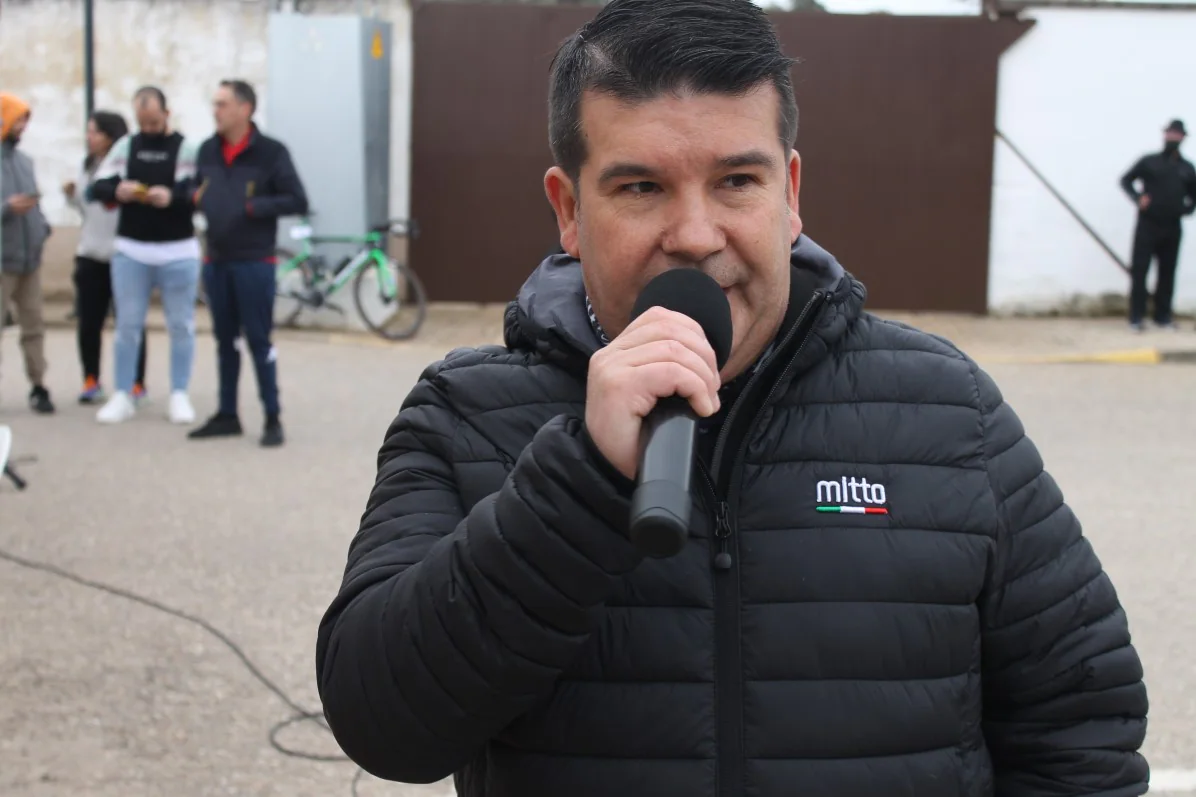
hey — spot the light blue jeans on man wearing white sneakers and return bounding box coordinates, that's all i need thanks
[112,253,200,393]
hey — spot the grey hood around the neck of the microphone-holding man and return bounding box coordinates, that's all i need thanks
[504,235,866,361]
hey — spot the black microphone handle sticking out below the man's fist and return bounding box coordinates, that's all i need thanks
[630,396,697,558]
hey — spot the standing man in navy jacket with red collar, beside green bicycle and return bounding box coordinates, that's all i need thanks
[188,80,307,446]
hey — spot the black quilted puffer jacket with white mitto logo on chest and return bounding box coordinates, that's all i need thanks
[317,238,1147,797]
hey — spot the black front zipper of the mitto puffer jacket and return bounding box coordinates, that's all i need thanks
[698,291,830,797]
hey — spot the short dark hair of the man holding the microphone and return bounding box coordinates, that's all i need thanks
[548,0,798,182]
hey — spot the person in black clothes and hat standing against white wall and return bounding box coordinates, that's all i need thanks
[1121,120,1196,331]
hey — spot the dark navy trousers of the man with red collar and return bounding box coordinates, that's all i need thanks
[203,261,279,418]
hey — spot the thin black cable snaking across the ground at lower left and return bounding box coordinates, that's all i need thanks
[0,549,365,797]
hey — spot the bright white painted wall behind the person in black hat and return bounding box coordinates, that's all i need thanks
[989,8,1196,312]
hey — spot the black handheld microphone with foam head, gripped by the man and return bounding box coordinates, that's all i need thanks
[630,268,732,559]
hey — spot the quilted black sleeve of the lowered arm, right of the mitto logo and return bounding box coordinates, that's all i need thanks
[977,363,1148,797]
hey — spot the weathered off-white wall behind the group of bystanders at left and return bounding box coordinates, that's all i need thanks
[0,0,411,301]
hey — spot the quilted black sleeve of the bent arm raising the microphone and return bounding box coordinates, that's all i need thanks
[316,361,640,783]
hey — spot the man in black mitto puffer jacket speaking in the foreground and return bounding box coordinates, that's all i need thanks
[317,0,1147,797]
